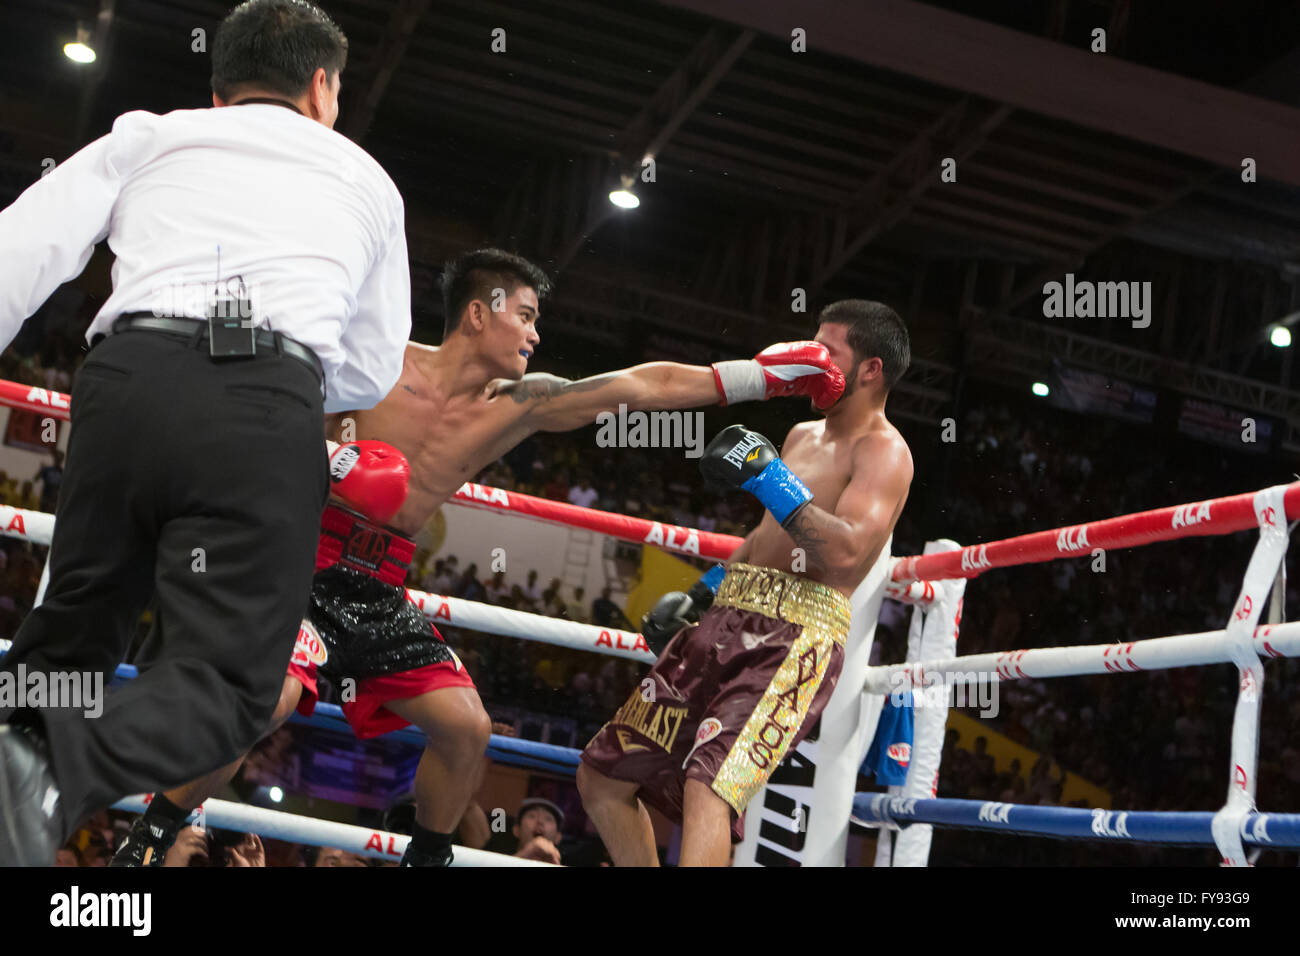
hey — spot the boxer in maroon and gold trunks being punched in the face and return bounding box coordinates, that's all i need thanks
[577,299,913,866]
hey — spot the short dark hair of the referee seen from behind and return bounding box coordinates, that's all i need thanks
[212,0,347,100]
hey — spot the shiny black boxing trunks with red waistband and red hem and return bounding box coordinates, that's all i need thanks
[289,502,475,740]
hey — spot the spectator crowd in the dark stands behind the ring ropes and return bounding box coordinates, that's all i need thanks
[0,335,1300,865]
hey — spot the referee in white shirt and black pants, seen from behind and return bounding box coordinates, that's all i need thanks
[0,0,411,865]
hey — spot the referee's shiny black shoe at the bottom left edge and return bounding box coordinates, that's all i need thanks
[0,723,62,866]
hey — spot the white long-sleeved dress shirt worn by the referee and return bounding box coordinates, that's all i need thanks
[0,103,411,412]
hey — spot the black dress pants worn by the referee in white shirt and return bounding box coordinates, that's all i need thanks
[0,330,329,832]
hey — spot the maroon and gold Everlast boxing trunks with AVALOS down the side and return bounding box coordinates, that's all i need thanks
[582,564,849,842]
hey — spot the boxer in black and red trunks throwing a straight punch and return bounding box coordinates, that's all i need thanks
[114,250,842,866]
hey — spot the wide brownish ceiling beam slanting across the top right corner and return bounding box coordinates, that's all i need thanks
[660,0,1300,185]
